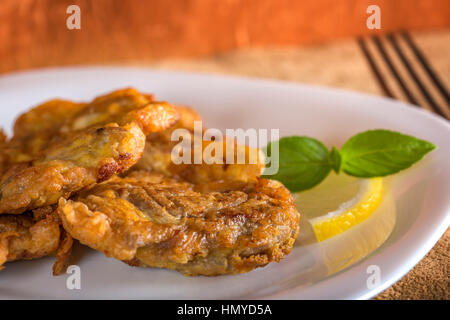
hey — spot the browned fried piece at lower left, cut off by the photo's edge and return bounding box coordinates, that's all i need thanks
[0,207,73,275]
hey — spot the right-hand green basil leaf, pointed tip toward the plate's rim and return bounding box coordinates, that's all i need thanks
[341,130,436,178]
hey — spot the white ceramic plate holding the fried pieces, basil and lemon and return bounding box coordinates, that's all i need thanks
[0,68,450,299]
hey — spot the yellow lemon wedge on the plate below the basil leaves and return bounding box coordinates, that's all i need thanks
[294,172,383,241]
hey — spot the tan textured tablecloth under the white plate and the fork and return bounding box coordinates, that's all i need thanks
[142,30,450,299]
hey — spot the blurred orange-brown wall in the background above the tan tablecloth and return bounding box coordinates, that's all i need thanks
[0,0,450,72]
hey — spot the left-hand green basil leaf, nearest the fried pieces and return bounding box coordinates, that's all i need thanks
[263,136,332,192]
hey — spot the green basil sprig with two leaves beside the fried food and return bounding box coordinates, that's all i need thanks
[264,130,436,192]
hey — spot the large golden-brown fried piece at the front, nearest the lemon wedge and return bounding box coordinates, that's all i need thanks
[57,172,300,276]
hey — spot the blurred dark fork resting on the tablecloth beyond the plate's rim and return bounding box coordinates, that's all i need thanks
[357,32,450,119]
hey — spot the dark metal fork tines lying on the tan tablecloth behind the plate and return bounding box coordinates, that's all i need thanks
[358,32,450,119]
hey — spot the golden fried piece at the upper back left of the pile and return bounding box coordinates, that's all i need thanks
[7,88,178,163]
